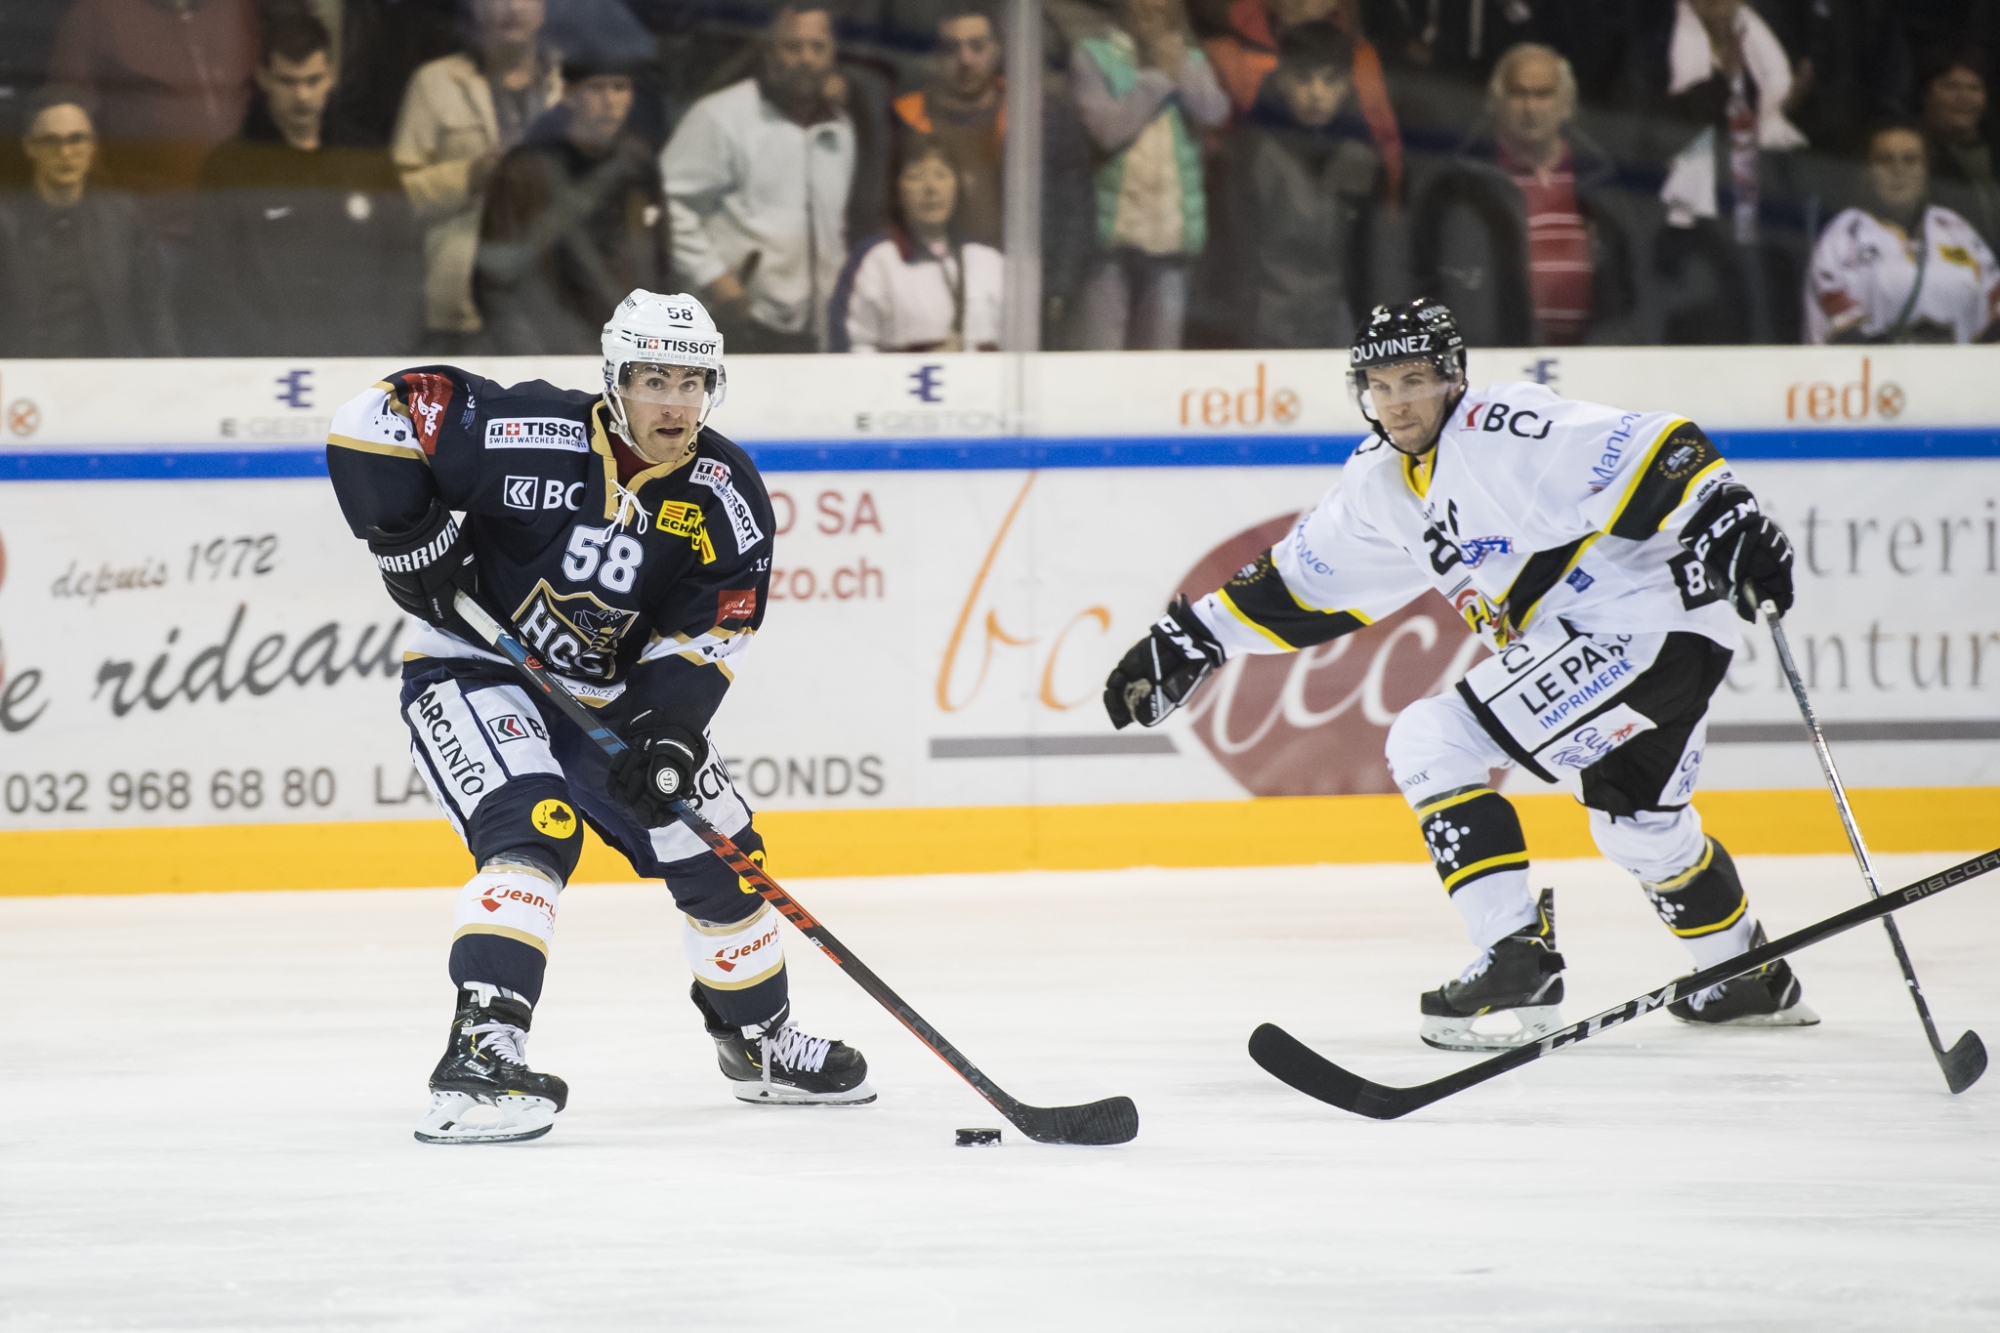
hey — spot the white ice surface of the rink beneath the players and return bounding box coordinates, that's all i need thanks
[0,857,2000,1333]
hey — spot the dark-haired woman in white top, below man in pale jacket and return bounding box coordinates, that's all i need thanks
[828,138,1006,352]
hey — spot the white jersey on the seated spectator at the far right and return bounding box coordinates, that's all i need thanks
[1806,208,2000,342]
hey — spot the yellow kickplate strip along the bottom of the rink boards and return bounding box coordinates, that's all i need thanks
[0,787,2000,897]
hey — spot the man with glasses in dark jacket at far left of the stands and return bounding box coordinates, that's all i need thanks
[0,90,176,356]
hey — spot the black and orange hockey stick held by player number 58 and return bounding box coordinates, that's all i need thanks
[456,592,1138,1143]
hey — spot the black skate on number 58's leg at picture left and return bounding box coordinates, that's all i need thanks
[416,983,570,1143]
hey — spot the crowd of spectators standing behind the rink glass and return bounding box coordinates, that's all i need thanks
[0,0,2000,356]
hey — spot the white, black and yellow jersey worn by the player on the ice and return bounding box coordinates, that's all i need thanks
[1194,382,1756,656]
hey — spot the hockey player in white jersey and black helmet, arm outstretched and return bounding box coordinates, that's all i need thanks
[1104,300,1818,1051]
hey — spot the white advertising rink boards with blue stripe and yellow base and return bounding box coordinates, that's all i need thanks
[0,348,2000,893]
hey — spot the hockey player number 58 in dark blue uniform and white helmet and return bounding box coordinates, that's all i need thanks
[326,292,874,1143]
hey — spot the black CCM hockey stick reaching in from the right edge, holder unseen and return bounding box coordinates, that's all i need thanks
[1250,849,2000,1121]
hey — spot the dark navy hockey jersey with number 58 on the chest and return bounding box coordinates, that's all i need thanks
[326,366,774,731]
